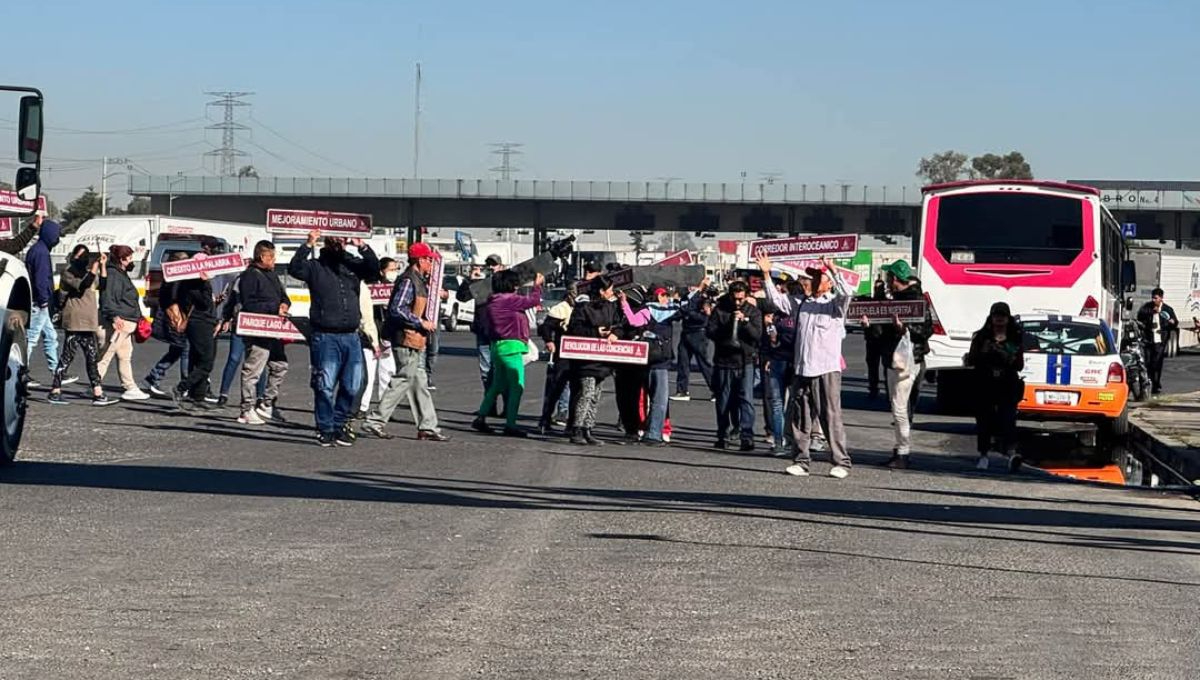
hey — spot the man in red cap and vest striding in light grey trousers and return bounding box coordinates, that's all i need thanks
[362,242,449,441]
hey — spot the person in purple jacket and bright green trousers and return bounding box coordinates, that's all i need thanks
[470,270,545,437]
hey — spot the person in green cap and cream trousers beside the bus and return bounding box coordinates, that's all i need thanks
[863,260,934,470]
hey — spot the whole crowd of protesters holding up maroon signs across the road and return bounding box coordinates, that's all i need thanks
[21,219,1041,479]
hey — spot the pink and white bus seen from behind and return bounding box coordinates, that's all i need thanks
[913,180,1135,405]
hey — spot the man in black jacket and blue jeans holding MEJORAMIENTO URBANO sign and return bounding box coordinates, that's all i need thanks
[288,230,379,446]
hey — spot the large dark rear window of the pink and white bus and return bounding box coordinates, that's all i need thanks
[937,192,1087,265]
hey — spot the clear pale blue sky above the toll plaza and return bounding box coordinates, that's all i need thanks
[9,0,1200,206]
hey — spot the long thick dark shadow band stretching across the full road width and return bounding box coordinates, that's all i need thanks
[0,462,1200,563]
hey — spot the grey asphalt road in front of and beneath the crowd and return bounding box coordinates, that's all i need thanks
[0,333,1200,679]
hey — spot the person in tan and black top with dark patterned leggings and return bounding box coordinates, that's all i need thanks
[48,245,116,407]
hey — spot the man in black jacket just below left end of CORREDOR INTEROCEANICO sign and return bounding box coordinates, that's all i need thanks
[708,281,762,451]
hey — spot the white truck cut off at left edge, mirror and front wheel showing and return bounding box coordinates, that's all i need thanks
[0,85,42,465]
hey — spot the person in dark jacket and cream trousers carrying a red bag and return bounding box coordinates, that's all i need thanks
[96,243,150,402]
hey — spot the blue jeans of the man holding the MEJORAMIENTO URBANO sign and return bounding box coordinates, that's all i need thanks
[308,331,366,434]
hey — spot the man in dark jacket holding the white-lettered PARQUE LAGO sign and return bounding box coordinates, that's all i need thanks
[236,241,292,425]
